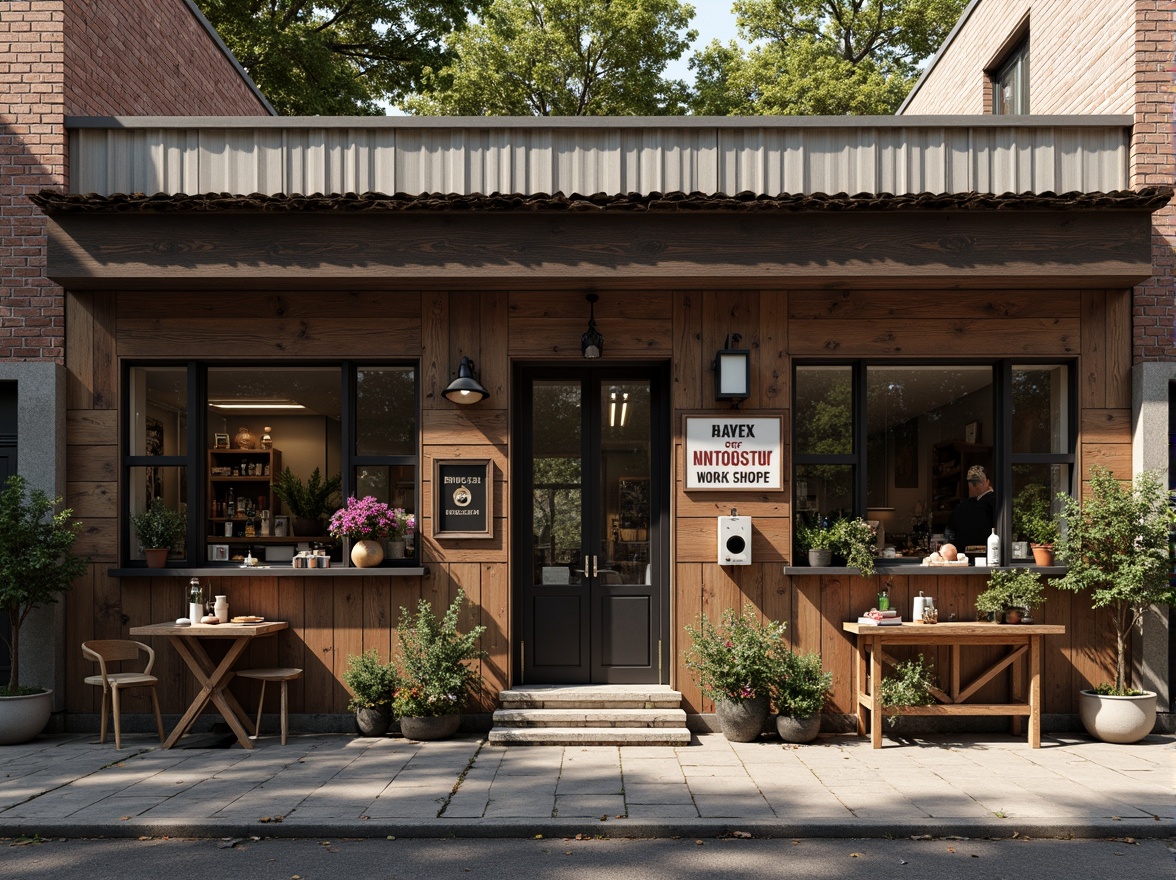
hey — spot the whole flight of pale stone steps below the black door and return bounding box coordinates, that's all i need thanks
[489,685,690,746]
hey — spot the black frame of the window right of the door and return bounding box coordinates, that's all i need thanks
[789,358,1080,565]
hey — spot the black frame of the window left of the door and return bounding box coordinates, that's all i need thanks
[118,358,423,571]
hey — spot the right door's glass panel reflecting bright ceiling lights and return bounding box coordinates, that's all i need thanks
[595,380,653,587]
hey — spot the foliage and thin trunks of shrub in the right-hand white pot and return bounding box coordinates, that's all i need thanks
[1054,466,1176,695]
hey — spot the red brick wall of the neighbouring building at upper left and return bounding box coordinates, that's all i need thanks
[0,0,266,361]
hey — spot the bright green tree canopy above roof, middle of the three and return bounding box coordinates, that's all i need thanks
[405,0,697,116]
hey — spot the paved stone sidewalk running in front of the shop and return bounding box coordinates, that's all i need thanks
[0,734,1176,838]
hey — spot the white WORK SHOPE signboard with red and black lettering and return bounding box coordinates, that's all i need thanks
[686,415,784,492]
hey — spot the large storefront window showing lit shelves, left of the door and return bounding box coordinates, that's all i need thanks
[121,364,419,565]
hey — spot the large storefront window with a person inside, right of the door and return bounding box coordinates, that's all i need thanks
[793,361,1075,561]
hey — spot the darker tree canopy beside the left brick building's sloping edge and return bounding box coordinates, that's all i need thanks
[196,0,486,115]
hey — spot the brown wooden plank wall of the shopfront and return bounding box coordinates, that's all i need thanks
[59,288,1130,713]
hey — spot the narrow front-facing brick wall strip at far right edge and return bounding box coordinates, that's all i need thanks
[1131,0,1176,362]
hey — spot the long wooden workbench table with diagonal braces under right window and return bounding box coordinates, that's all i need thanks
[842,622,1065,748]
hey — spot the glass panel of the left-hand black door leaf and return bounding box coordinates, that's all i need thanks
[532,380,583,586]
